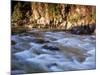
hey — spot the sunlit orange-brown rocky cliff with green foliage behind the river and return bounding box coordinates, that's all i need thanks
[12,1,96,34]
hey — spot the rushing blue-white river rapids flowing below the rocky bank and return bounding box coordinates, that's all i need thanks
[11,30,96,75]
